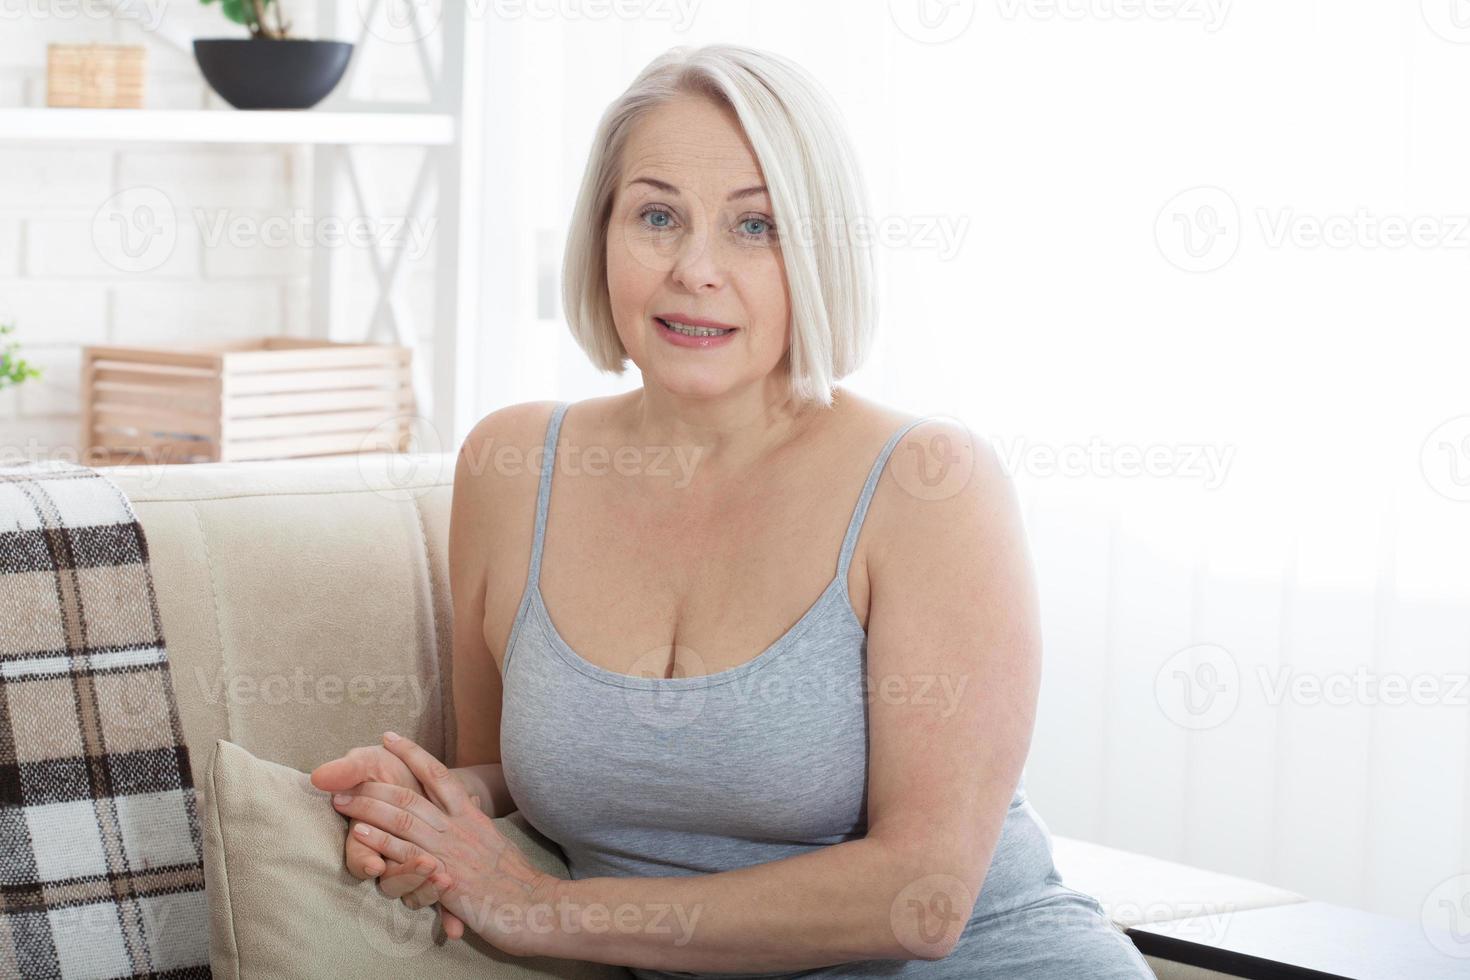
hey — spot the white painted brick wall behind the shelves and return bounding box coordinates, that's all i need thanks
[0,0,434,458]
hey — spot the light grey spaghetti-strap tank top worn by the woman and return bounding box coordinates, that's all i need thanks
[501,401,1091,980]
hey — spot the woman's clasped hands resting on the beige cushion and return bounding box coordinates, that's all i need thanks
[312,732,557,955]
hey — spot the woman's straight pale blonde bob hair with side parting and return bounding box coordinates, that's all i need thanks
[562,44,878,406]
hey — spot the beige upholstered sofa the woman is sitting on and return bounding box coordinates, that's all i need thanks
[101,454,1304,980]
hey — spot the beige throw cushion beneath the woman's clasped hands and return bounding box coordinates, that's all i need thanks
[201,739,632,980]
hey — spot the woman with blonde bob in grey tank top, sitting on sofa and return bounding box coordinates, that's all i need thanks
[313,46,1152,980]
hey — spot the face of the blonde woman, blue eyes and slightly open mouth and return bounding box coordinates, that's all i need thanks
[607,96,791,397]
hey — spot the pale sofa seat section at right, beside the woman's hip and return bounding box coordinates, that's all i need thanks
[1053,836,1305,929]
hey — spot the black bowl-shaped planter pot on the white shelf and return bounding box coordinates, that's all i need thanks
[194,38,353,109]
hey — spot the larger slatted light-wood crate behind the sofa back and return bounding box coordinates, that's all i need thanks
[81,336,416,466]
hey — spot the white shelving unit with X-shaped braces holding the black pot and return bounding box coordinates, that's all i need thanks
[0,0,487,451]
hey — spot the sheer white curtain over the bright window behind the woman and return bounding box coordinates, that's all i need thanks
[482,0,1470,917]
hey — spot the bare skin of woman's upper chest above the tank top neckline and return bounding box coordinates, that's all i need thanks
[485,473,870,677]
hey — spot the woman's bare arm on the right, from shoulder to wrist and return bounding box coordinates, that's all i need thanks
[511,422,1041,973]
